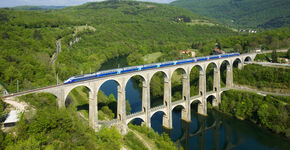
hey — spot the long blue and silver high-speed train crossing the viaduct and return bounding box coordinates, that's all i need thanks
[64,53,240,84]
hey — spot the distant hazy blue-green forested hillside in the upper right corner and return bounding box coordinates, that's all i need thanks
[171,0,290,29]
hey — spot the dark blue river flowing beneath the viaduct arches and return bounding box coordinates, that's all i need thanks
[101,57,290,150]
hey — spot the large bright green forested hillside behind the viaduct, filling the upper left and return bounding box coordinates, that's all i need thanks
[0,1,236,92]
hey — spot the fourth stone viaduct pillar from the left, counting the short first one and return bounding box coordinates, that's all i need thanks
[142,80,151,127]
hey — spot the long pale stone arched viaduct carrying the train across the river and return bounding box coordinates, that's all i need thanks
[3,53,256,132]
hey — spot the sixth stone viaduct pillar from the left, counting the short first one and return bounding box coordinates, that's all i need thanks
[181,74,191,122]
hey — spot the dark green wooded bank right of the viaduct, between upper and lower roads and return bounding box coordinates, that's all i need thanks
[233,64,290,90]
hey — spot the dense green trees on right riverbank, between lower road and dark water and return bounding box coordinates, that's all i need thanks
[221,90,290,137]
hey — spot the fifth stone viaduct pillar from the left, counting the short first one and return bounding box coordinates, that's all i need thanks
[163,78,172,129]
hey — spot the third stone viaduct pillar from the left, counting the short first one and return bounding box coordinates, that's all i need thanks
[117,84,127,135]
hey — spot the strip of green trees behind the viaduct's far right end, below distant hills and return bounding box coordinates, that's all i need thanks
[192,28,290,53]
